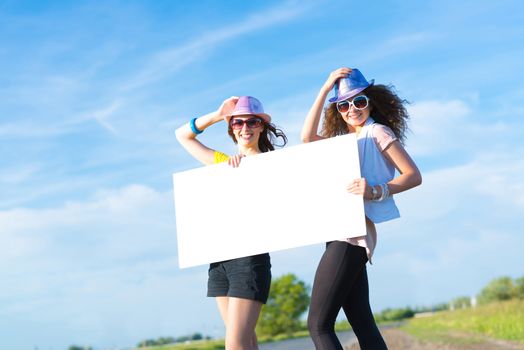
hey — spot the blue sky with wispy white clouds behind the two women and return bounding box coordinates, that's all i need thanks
[0,1,524,350]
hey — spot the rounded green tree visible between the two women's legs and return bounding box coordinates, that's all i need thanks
[257,273,309,335]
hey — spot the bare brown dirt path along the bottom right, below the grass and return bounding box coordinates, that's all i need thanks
[345,328,524,350]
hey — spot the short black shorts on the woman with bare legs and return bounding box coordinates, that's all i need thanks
[207,253,271,304]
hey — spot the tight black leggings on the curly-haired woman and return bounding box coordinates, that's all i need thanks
[307,241,387,350]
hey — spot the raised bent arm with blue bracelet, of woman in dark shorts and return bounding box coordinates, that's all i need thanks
[176,96,238,165]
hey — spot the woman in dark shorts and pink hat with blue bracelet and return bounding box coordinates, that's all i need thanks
[176,96,287,350]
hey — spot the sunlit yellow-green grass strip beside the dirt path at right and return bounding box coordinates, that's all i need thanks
[402,300,524,343]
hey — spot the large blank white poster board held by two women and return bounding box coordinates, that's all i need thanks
[173,134,366,268]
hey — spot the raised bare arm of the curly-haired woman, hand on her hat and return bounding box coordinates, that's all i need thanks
[301,67,351,143]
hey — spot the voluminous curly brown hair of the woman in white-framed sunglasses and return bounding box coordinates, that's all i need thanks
[321,85,409,144]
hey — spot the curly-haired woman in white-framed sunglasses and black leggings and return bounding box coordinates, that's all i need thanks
[302,68,422,350]
